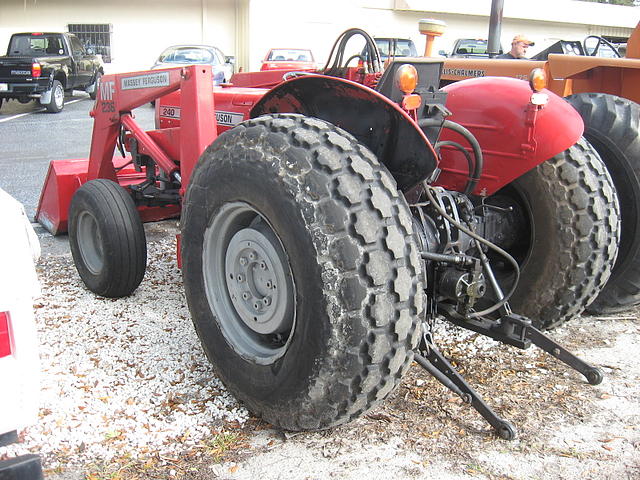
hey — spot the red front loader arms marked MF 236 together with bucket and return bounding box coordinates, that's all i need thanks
[36,66,217,235]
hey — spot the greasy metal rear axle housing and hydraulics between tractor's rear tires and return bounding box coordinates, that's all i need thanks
[411,181,526,322]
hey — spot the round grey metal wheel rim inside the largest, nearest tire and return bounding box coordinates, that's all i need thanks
[202,202,296,365]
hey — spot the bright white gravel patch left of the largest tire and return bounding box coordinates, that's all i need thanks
[0,231,248,468]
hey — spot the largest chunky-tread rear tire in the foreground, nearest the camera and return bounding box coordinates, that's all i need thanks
[181,114,424,430]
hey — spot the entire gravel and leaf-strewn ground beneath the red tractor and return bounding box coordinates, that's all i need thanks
[0,222,640,480]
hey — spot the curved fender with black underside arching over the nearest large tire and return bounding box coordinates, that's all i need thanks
[251,75,437,192]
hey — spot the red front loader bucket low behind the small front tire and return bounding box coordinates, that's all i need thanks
[35,157,180,235]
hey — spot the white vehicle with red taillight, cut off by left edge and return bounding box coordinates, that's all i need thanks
[0,189,42,480]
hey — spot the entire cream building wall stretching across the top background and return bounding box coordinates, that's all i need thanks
[0,0,640,72]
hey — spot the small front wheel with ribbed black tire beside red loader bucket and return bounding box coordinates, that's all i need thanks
[69,179,147,298]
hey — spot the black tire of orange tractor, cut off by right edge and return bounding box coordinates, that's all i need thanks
[566,93,640,314]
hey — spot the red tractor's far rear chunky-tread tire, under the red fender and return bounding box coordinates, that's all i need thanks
[490,140,619,329]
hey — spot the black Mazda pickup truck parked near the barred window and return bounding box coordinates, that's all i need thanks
[0,33,104,113]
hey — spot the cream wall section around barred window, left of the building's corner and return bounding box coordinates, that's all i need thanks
[0,0,236,72]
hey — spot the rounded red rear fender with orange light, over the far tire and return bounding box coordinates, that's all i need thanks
[437,77,584,195]
